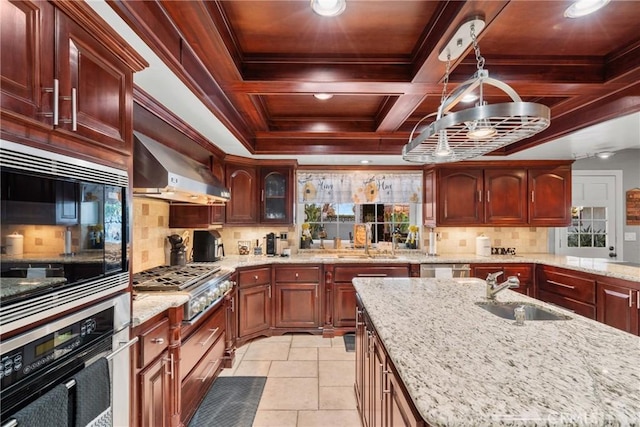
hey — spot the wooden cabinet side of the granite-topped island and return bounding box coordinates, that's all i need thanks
[354,301,425,427]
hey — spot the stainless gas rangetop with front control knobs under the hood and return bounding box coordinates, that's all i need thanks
[133,263,233,322]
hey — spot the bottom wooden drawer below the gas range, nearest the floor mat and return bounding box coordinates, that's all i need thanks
[181,337,224,420]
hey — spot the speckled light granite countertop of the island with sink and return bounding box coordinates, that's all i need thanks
[353,278,640,426]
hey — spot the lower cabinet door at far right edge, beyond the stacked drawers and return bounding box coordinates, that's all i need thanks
[596,280,640,335]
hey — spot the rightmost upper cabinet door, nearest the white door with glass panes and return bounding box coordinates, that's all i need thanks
[529,166,571,227]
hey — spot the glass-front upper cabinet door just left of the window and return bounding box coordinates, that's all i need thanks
[260,169,293,224]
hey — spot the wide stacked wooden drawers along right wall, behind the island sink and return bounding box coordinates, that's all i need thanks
[536,264,596,319]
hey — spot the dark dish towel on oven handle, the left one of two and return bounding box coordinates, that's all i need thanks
[11,384,69,427]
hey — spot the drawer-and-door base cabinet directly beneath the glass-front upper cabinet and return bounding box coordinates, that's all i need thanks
[274,265,322,331]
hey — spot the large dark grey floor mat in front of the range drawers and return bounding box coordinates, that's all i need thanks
[189,377,267,427]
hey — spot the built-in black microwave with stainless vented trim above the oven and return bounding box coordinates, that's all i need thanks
[0,140,130,338]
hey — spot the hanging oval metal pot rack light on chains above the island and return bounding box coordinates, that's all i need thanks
[402,18,551,163]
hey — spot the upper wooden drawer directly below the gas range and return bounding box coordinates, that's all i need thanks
[180,307,225,379]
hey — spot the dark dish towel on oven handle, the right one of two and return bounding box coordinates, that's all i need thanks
[73,357,111,426]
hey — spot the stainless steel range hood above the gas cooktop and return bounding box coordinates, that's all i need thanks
[133,132,231,205]
